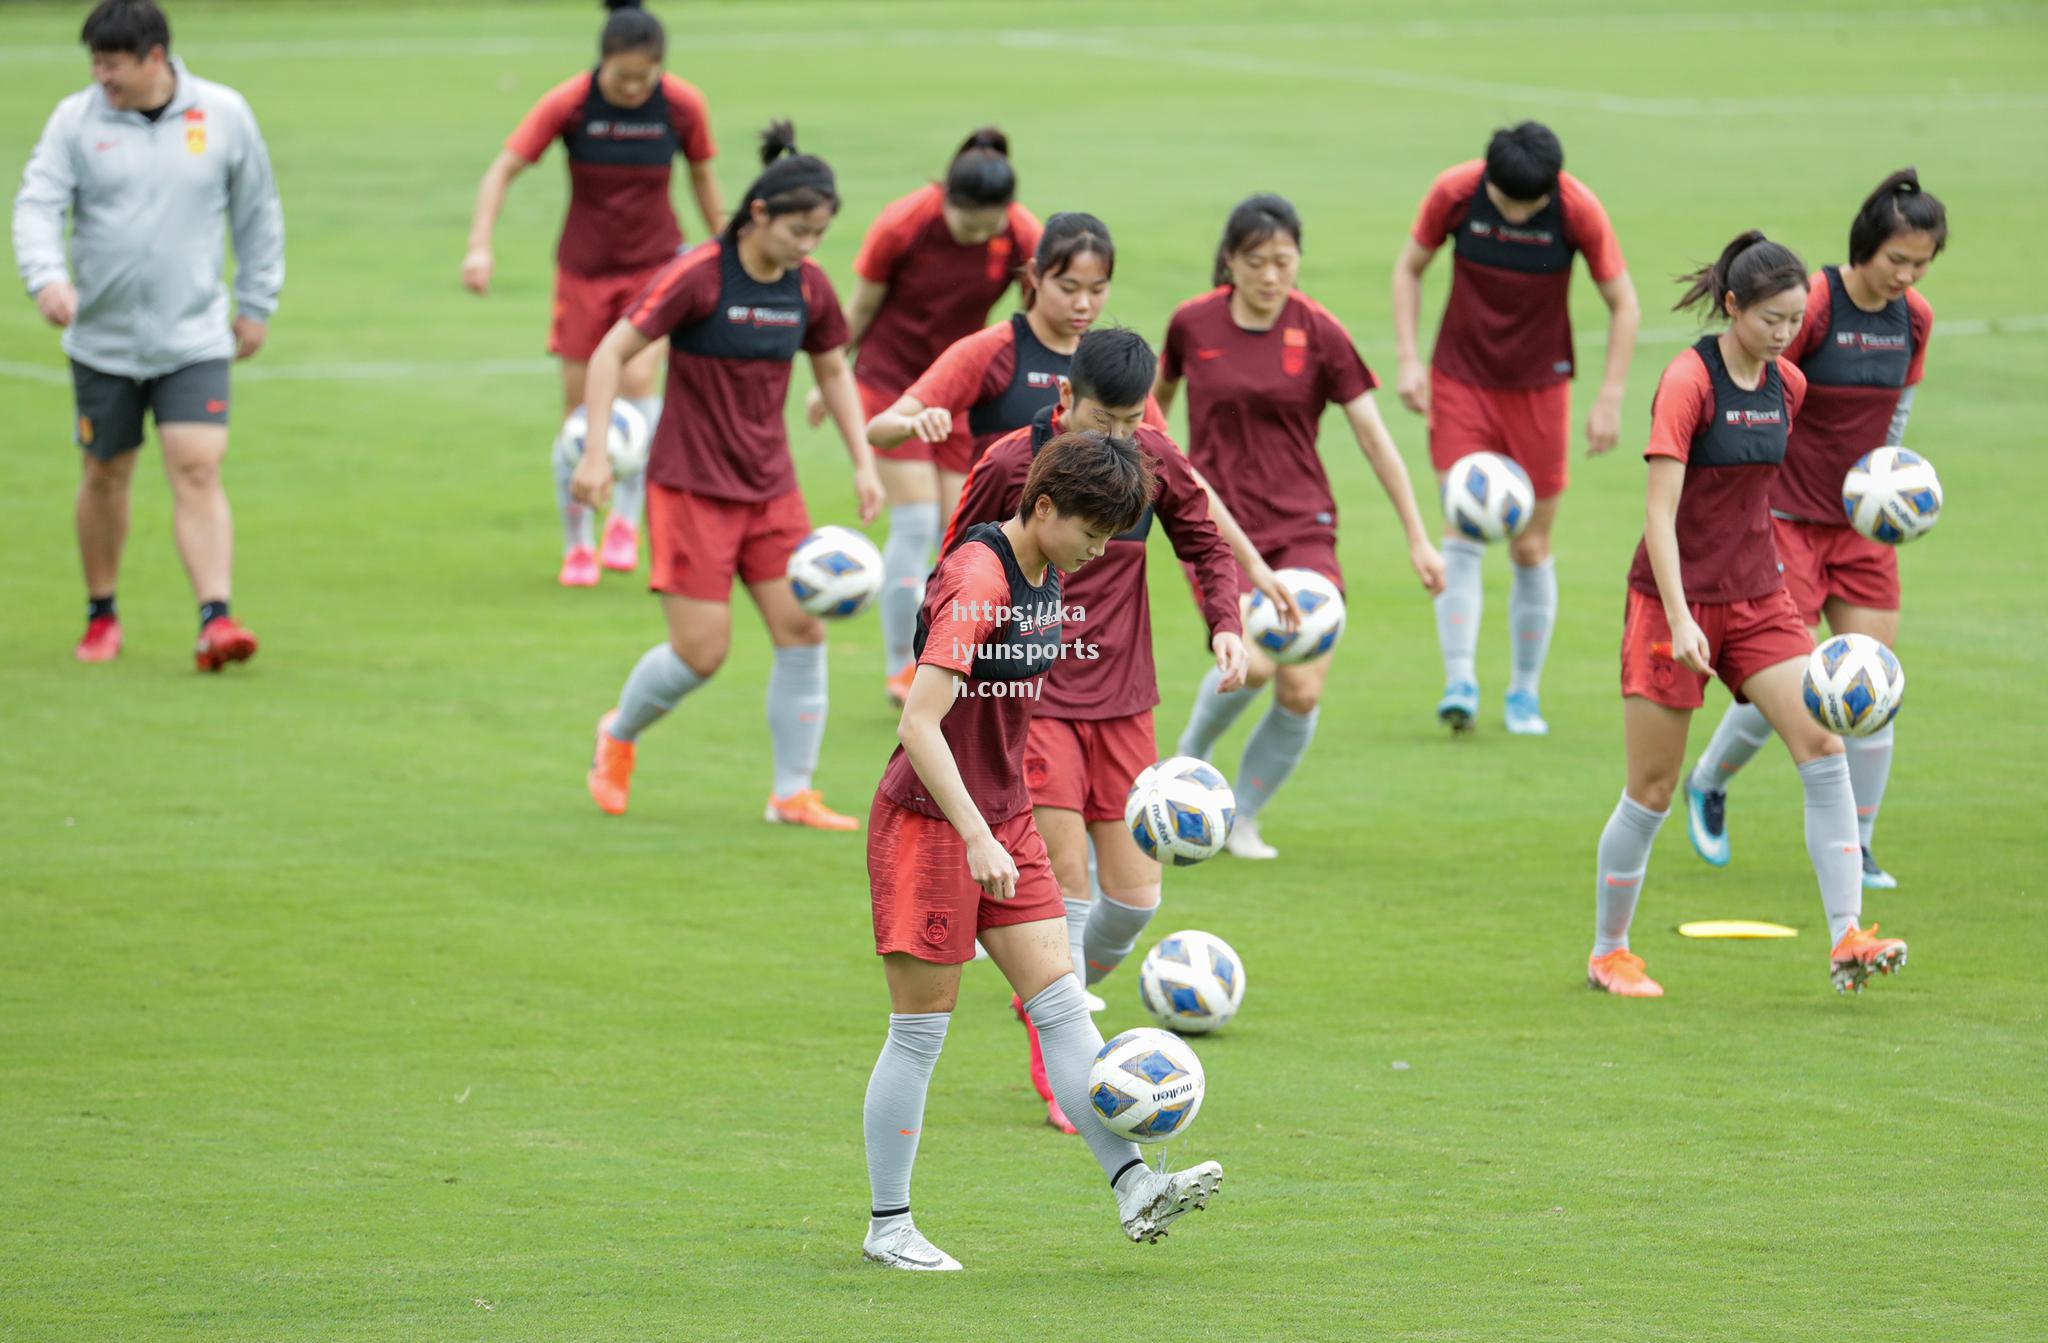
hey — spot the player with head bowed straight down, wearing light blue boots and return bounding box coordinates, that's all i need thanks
[1395,121,1642,735]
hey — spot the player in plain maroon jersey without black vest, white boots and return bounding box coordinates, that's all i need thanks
[1153,194,1444,858]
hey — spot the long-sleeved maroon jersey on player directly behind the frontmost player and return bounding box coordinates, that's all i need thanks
[940,405,1243,719]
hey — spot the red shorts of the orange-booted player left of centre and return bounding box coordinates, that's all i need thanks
[647,481,811,602]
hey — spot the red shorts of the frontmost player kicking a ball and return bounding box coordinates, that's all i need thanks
[868,794,1067,964]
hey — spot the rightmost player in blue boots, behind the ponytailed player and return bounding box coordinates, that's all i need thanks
[1686,168,1948,891]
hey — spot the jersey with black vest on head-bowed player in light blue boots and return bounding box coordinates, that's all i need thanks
[1411,160,1626,389]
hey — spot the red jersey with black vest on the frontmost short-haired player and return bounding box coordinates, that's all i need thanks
[874,526,1061,825]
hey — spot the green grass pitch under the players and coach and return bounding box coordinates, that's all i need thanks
[0,0,2048,1341]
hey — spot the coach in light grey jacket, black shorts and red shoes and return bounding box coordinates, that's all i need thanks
[14,0,285,672]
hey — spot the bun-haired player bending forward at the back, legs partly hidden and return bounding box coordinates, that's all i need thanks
[805,127,1038,702]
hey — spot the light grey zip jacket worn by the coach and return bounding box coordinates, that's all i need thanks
[14,57,285,379]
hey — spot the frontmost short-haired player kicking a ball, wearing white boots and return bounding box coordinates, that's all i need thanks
[862,432,1223,1269]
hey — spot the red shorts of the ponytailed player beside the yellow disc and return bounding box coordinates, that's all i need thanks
[1622,588,1812,708]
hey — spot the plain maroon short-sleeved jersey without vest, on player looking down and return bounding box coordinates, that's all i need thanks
[1159,285,1378,553]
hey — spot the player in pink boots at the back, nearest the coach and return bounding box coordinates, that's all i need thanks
[463,0,725,588]
